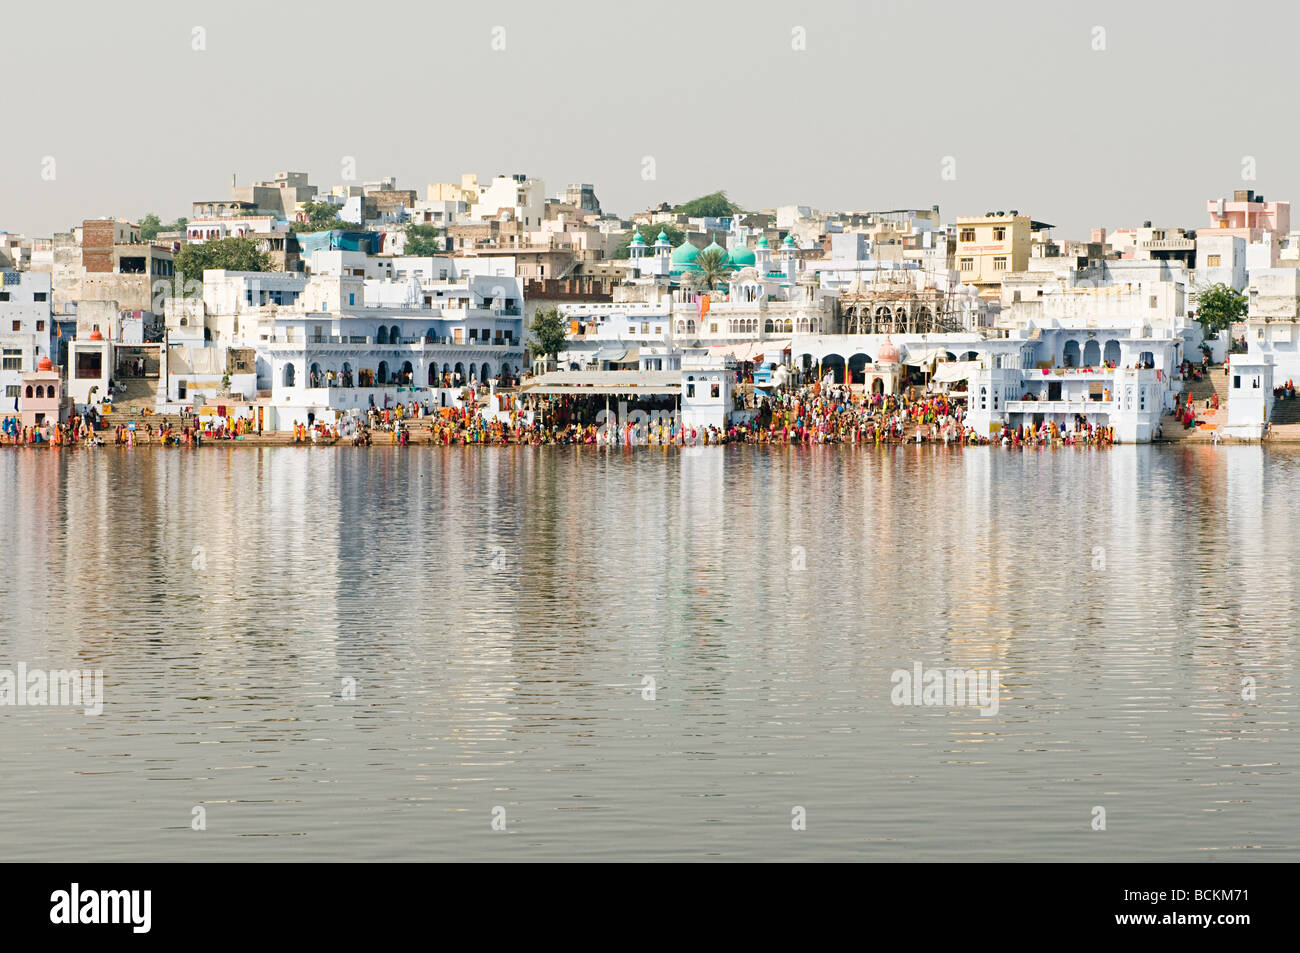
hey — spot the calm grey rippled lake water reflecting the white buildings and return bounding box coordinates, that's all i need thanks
[0,446,1300,861]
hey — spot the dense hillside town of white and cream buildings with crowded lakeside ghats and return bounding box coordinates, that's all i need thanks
[0,172,1300,447]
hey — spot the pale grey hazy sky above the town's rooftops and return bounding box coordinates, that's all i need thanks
[0,0,1300,238]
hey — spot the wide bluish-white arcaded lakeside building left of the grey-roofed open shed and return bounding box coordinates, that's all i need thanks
[165,260,524,429]
